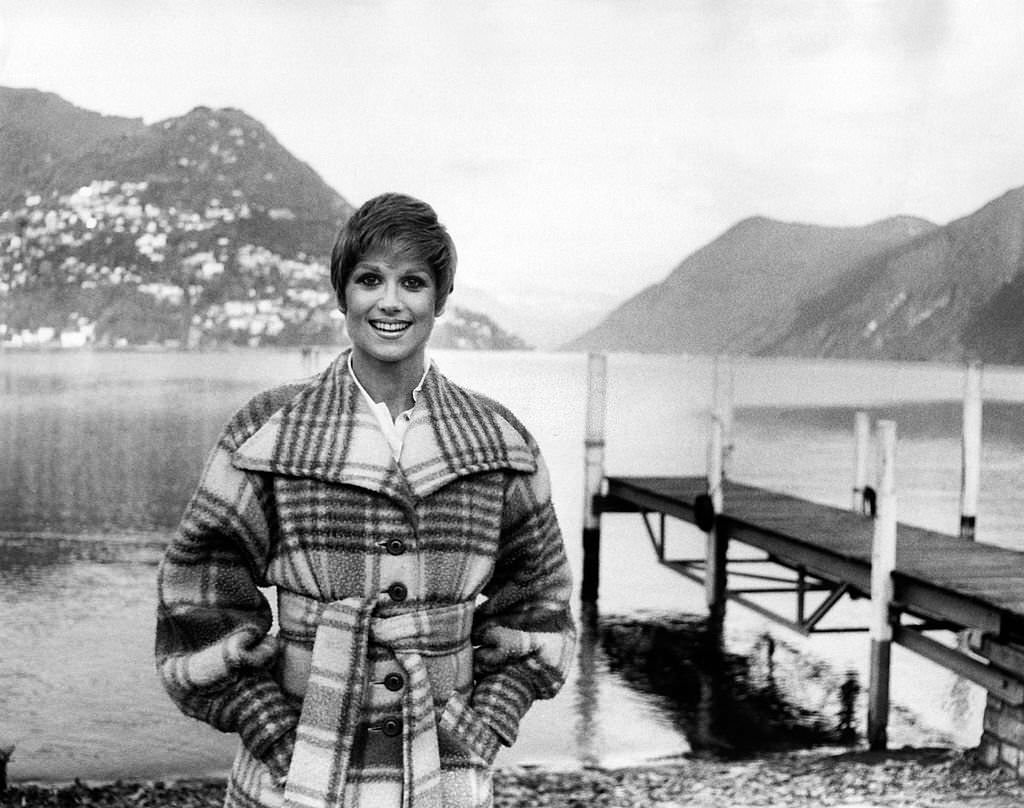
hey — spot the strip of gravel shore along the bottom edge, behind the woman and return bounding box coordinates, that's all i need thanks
[8,749,1024,808]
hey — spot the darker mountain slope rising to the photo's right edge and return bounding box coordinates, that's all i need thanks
[768,188,1024,363]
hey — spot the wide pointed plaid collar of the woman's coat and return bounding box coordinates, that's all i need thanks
[232,352,537,505]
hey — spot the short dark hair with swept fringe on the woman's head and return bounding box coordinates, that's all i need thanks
[331,194,458,312]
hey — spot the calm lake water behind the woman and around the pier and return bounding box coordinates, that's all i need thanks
[0,351,1024,780]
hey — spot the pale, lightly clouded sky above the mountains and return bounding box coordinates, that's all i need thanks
[0,0,1024,345]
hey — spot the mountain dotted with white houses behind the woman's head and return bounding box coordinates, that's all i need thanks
[0,88,522,348]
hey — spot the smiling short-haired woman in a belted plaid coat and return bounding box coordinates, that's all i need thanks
[157,194,574,808]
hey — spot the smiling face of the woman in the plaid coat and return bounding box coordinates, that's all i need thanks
[345,252,439,372]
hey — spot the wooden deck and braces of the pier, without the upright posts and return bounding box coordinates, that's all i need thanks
[600,477,1024,688]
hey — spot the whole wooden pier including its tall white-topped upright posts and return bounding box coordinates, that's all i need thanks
[582,355,1024,777]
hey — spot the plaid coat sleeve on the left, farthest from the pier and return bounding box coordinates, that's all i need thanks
[156,428,298,776]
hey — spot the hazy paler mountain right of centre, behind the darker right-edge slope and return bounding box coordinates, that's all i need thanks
[566,216,937,354]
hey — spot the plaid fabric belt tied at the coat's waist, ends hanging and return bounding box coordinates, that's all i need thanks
[279,590,473,808]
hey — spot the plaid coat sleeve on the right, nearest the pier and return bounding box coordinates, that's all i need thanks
[471,450,575,746]
